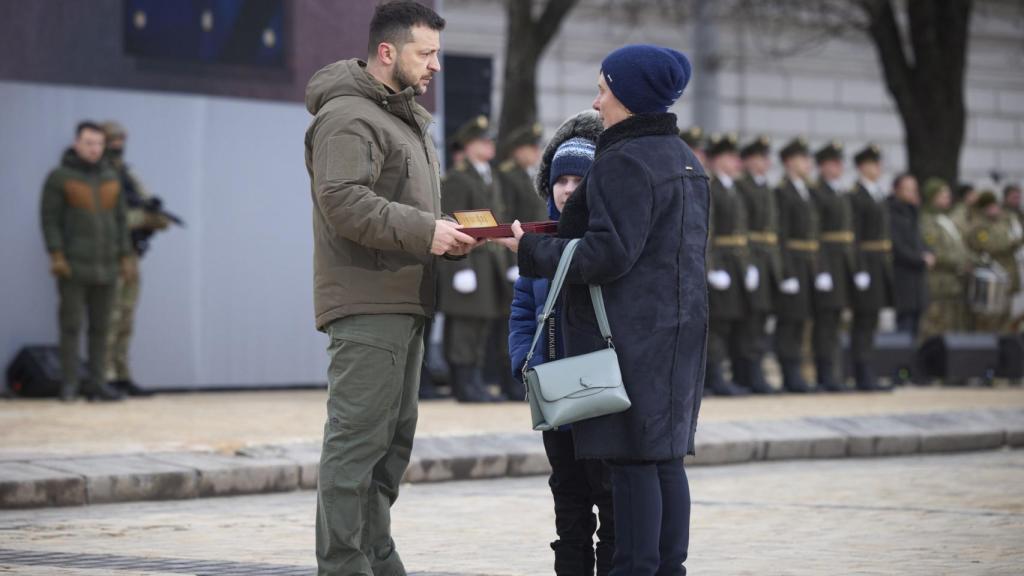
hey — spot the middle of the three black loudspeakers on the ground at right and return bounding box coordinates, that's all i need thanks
[918,332,999,379]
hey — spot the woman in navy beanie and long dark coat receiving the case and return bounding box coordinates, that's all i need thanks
[500,45,709,576]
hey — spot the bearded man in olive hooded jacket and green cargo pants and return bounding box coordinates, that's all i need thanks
[305,1,474,576]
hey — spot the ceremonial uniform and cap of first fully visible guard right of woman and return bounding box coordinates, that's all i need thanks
[705,134,751,396]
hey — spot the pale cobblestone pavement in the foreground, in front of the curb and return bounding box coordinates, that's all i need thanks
[0,451,1024,576]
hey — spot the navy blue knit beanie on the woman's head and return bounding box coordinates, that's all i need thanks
[601,44,690,114]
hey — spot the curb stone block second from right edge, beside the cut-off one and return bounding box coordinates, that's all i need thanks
[892,412,1007,453]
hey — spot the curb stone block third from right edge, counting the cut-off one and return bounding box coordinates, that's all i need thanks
[807,416,921,457]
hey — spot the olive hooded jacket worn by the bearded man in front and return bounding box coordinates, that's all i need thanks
[305,59,440,329]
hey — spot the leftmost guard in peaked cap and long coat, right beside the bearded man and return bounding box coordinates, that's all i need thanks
[438,116,512,402]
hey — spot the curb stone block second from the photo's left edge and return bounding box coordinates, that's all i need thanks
[33,455,199,504]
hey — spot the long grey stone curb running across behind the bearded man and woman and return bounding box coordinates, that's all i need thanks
[0,409,1024,509]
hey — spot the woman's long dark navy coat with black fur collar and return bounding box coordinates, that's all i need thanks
[518,114,710,460]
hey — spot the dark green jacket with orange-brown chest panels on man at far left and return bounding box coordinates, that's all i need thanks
[40,150,132,284]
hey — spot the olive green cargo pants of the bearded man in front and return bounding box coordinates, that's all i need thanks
[316,315,425,576]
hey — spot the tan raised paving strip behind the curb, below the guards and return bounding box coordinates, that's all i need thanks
[6,387,1024,459]
